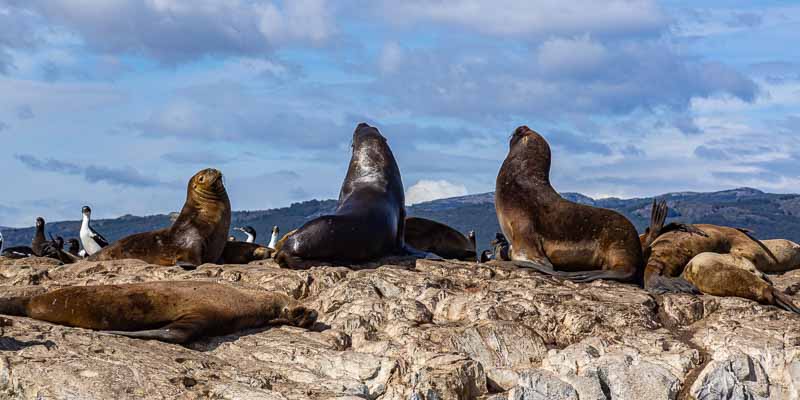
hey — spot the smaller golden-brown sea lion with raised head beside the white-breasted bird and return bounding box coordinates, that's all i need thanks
[89,169,231,267]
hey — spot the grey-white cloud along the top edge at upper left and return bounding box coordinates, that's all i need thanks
[14,0,335,63]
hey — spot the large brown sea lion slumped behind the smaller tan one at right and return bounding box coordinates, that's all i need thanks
[644,224,777,297]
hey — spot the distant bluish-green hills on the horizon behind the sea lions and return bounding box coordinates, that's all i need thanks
[2,188,800,248]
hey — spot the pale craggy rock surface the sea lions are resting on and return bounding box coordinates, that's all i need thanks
[0,258,800,400]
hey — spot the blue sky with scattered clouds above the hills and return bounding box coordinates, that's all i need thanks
[0,0,800,226]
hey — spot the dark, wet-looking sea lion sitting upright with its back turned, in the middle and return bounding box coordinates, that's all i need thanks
[275,123,432,267]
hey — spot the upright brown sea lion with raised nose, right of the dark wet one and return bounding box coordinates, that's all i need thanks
[495,126,656,282]
